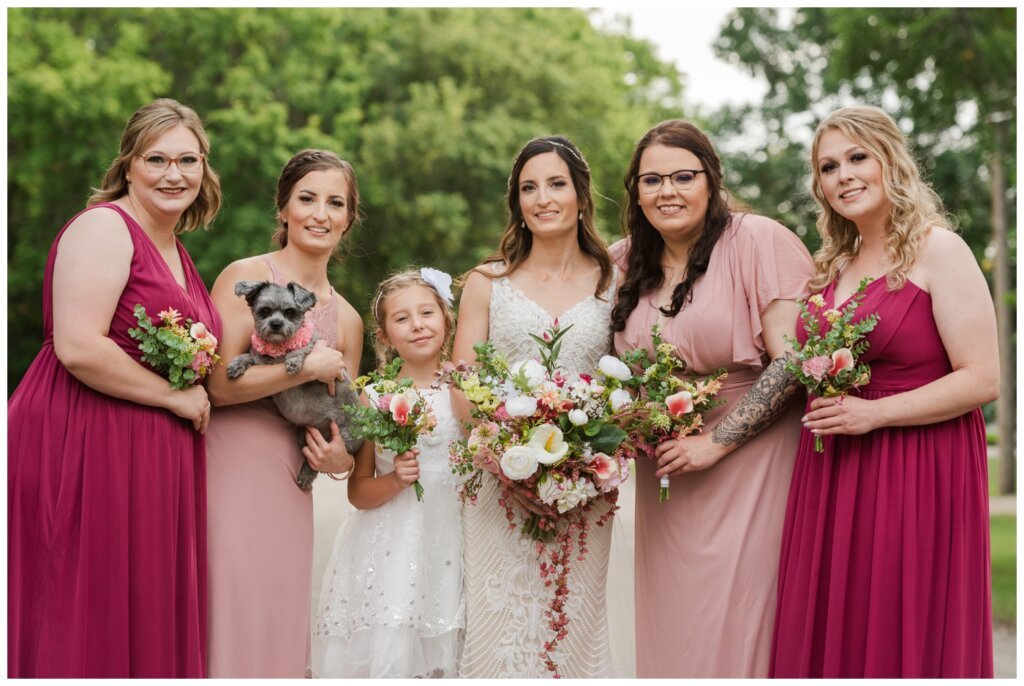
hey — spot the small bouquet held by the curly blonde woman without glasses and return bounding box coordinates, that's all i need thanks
[785,276,879,453]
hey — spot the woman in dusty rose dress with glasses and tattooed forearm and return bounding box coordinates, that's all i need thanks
[611,120,813,678]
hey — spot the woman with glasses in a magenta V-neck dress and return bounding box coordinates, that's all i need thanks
[7,99,220,678]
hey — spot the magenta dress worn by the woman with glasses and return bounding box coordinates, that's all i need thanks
[7,203,220,678]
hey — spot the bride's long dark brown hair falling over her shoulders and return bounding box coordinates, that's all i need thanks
[475,136,611,298]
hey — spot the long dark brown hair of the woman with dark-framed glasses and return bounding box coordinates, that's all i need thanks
[611,119,730,331]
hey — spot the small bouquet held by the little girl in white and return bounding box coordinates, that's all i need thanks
[345,357,437,503]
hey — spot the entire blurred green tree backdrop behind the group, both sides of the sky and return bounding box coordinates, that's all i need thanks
[7,8,1016,416]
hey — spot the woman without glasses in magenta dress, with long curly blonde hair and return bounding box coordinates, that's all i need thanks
[771,106,999,678]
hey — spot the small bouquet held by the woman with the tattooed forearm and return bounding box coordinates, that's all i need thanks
[616,324,728,503]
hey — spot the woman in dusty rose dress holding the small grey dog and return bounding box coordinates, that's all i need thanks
[208,151,362,679]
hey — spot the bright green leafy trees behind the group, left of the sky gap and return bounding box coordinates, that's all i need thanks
[8,8,682,390]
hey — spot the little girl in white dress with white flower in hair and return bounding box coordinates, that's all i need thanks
[311,268,465,678]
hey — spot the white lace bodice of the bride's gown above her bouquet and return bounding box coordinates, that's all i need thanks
[487,269,618,377]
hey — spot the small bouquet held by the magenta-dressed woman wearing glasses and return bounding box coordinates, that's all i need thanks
[128,304,220,390]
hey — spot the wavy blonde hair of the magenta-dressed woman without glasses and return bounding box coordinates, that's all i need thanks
[810,105,953,291]
